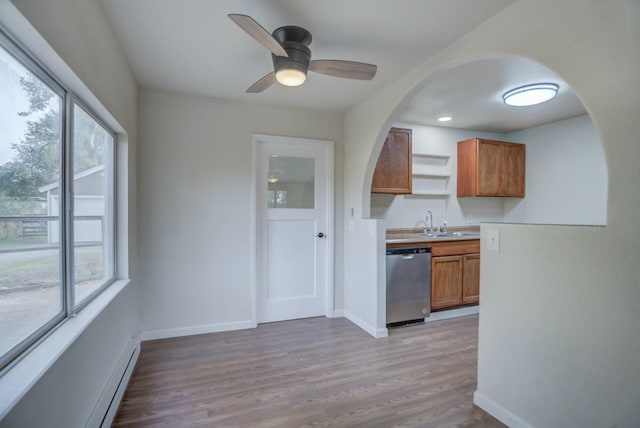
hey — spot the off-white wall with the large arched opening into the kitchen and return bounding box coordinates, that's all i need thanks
[345,0,640,427]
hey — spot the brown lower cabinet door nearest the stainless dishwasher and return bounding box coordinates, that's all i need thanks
[431,256,463,309]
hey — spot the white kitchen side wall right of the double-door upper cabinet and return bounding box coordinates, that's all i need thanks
[504,115,608,225]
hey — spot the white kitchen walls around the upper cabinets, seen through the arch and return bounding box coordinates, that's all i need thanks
[378,115,608,228]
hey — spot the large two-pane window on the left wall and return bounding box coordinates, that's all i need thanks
[0,33,115,368]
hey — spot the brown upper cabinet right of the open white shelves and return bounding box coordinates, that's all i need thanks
[458,138,525,198]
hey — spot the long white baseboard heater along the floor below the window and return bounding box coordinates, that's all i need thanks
[84,337,140,428]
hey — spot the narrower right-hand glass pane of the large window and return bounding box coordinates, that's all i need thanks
[73,104,115,305]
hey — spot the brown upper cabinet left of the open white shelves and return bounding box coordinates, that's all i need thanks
[371,128,412,195]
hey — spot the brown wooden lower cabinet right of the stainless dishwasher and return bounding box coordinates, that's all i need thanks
[431,240,480,310]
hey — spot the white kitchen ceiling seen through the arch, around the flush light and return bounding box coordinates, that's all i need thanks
[398,57,586,133]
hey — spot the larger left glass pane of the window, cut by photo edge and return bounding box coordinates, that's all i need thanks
[0,47,63,366]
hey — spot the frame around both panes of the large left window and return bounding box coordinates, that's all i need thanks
[0,27,118,376]
